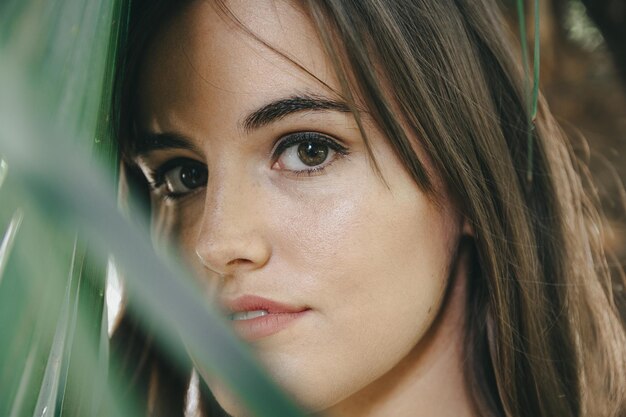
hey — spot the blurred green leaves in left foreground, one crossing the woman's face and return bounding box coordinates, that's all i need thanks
[0,0,301,417]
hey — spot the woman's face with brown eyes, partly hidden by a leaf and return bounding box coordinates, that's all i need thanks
[137,0,461,413]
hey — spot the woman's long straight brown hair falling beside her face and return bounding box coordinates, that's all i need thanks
[113,0,626,417]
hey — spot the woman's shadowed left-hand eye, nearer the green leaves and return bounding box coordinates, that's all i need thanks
[152,158,208,197]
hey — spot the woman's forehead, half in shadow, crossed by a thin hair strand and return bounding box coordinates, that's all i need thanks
[138,0,338,132]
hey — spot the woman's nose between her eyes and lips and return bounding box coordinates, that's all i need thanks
[196,177,271,276]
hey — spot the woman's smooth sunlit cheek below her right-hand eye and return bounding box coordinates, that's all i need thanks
[270,169,456,309]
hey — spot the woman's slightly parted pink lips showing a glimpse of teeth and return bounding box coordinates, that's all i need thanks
[222,295,310,341]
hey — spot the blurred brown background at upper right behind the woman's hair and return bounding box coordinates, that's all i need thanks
[500,0,626,272]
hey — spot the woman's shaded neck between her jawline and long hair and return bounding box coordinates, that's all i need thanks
[324,243,475,417]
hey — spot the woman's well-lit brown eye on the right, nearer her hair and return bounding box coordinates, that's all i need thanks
[272,132,348,174]
